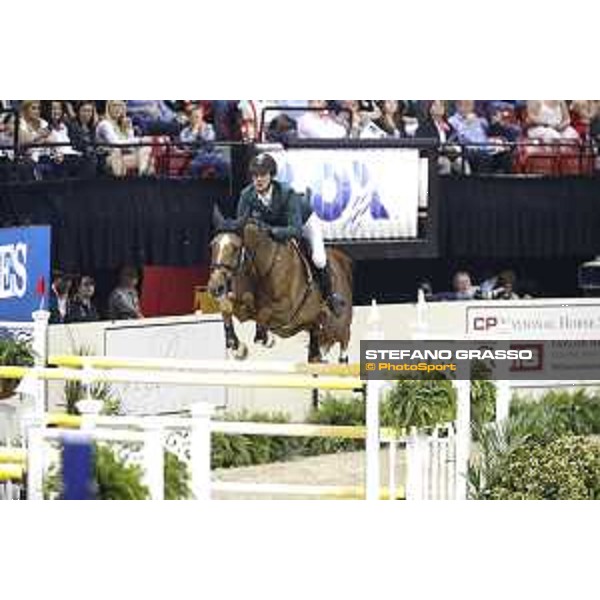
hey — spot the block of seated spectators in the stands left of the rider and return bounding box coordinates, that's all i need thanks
[0,100,230,179]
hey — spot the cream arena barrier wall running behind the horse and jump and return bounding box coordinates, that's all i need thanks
[50,298,600,421]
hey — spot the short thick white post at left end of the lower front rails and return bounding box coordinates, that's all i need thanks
[190,402,213,500]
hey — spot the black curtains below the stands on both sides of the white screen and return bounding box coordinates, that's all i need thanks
[0,177,600,271]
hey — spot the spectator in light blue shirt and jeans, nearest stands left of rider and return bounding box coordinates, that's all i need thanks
[179,106,229,179]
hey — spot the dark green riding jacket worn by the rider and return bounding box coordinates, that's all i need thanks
[237,181,312,241]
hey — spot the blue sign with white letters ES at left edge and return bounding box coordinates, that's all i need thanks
[0,226,51,321]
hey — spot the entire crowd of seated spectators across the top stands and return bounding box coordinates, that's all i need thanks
[0,100,600,178]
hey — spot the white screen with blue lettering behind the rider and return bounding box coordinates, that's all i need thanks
[272,148,427,240]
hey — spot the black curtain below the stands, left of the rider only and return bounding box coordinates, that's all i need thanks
[0,179,232,271]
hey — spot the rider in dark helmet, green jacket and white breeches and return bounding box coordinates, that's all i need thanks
[237,153,344,317]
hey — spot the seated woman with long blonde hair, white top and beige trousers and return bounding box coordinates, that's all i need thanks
[96,100,151,177]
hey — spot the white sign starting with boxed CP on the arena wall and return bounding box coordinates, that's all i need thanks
[466,303,600,340]
